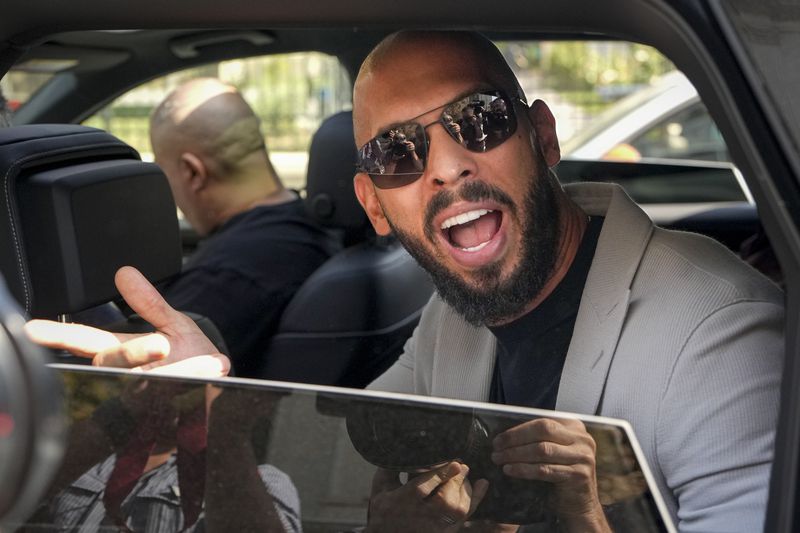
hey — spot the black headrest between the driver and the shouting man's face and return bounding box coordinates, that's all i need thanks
[306,111,372,243]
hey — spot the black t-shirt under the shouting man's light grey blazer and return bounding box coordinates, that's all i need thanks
[489,217,603,409]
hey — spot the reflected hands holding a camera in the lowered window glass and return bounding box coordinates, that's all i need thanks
[366,418,596,533]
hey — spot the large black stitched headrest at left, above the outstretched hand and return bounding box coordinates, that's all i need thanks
[0,125,181,317]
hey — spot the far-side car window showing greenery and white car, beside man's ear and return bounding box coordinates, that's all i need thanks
[499,41,729,161]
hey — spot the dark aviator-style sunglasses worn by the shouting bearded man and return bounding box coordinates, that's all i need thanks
[356,90,525,189]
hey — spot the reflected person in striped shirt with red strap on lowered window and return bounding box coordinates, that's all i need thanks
[31,380,301,533]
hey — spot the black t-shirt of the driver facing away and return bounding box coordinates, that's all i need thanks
[162,199,340,377]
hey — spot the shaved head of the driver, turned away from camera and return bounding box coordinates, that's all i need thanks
[150,78,294,235]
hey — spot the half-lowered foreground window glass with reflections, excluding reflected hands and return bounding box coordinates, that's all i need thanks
[17,366,670,532]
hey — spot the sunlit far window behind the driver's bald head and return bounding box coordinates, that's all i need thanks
[84,52,352,189]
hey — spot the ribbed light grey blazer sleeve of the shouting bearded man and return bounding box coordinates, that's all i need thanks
[655,301,783,533]
